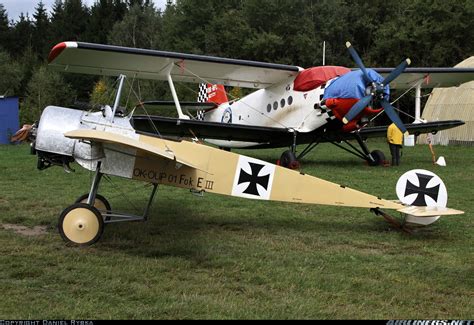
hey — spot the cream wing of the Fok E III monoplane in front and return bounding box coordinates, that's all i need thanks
[64,130,205,170]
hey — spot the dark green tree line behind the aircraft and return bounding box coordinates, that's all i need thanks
[0,0,474,123]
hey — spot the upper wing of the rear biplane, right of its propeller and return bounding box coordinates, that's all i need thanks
[374,68,474,89]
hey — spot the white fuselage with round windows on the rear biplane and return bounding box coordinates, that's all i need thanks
[204,78,333,148]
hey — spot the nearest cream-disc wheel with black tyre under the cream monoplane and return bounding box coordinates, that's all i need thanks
[58,203,104,246]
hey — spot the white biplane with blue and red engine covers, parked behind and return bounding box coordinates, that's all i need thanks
[45,42,474,167]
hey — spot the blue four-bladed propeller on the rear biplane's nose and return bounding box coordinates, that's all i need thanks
[342,42,411,133]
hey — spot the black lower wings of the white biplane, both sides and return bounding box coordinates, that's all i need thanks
[132,115,464,148]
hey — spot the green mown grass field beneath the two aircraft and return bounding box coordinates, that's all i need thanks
[0,141,474,319]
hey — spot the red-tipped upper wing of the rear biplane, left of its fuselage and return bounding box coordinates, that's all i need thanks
[48,42,301,88]
